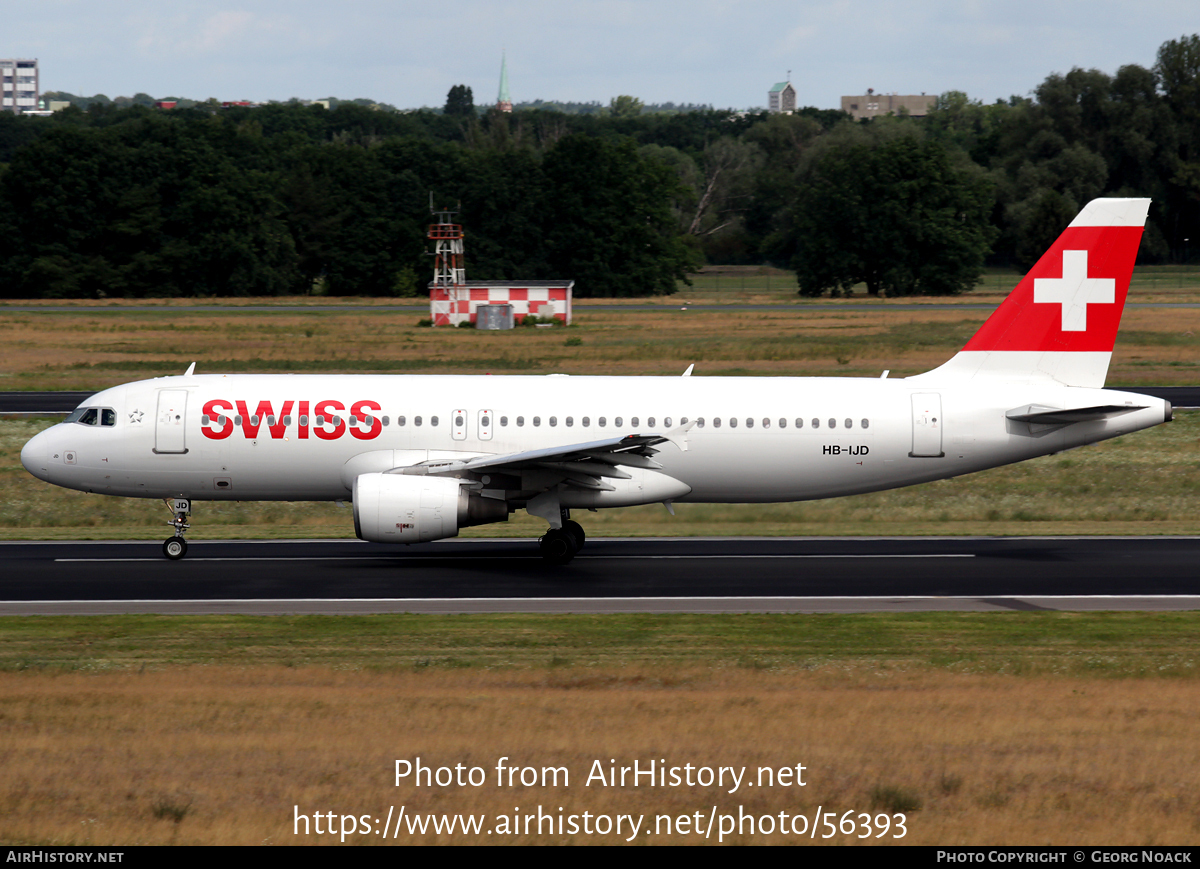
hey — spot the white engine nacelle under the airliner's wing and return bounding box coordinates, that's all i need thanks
[354,474,509,544]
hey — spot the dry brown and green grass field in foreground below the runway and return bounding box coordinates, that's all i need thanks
[7,613,1200,845]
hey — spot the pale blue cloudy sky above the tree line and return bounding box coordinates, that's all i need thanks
[9,0,1200,108]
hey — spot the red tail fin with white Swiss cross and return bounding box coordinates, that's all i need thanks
[913,199,1150,388]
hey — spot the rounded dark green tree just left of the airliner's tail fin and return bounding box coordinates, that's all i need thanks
[792,133,994,295]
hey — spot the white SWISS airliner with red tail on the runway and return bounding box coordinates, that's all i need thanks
[20,199,1171,563]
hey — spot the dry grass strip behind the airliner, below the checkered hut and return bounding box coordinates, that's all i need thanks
[0,295,1200,390]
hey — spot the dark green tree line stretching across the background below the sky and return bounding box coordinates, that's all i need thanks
[0,35,1200,298]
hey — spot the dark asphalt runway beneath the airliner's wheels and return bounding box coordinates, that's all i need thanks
[7,538,1200,615]
